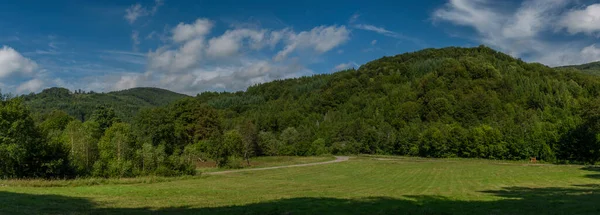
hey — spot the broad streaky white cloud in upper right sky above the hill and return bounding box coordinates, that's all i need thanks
[432,0,600,66]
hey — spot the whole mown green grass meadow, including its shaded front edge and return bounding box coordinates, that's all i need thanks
[0,157,600,214]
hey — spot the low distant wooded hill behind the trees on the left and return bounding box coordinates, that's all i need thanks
[23,88,188,121]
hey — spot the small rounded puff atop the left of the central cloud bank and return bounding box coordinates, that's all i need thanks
[172,19,213,42]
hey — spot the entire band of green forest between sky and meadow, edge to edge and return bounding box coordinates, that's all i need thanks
[0,46,600,178]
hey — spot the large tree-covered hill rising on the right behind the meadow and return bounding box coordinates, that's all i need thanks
[198,46,600,162]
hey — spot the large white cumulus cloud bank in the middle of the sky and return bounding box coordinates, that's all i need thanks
[143,19,349,94]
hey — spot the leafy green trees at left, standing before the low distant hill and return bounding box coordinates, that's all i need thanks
[0,98,221,178]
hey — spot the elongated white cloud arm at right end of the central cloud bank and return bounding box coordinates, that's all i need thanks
[274,26,350,61]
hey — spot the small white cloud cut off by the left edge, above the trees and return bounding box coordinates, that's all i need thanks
[0,46,38,79]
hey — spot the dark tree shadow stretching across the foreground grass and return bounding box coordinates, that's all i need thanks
[0,184,600,215]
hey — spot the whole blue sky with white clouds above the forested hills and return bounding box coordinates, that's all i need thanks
[0,0,600,95]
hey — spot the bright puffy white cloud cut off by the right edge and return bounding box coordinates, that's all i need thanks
[558,4,600,35]
